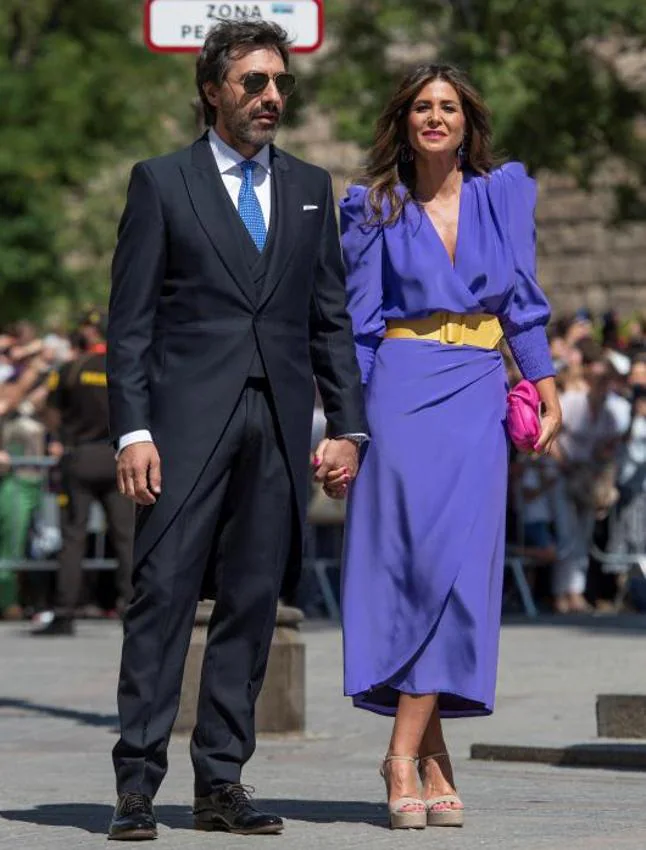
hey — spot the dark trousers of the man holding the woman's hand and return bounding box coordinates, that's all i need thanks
[113,382,294,796]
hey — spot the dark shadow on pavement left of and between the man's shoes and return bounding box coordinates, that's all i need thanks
[0,803,193,834]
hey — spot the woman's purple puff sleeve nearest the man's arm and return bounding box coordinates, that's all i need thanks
[340,186,386,385]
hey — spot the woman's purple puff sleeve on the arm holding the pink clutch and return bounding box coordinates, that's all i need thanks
[498,162,554,381]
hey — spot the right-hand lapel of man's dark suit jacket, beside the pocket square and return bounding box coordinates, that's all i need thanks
[258,148,302,307]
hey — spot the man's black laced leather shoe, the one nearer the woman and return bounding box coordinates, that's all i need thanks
[193,785,284,835]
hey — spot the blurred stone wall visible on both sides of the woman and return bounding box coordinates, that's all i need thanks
[279,112,646,315]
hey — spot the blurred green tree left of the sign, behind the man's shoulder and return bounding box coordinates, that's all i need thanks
[0,0,191,321]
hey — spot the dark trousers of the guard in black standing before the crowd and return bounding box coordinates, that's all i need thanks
[56,443,134,617]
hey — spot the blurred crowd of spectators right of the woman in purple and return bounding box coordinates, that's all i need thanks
[508,310,646,614]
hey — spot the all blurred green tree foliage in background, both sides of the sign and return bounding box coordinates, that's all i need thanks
[0,0,646,321]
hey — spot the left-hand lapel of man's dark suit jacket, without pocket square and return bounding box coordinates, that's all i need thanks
[182,134,257,306]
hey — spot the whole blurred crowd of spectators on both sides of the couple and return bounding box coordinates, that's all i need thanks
[0,310,646,617]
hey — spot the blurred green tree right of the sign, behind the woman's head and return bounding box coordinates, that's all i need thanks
[311,0,646,205]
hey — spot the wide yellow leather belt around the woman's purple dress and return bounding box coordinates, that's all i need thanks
[385,310,503,349]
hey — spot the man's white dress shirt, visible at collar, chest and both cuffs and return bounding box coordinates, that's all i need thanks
[117,128,367,456]
